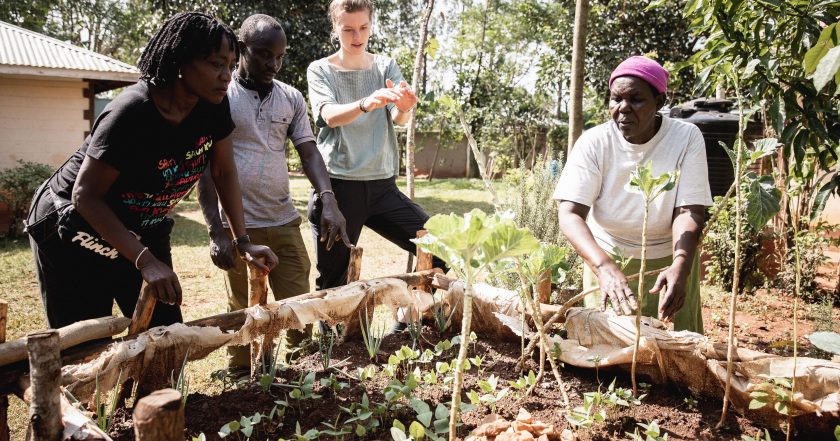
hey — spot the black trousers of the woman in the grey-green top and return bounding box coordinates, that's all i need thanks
[308,178,445,289]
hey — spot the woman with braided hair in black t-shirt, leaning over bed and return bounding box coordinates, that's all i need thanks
[27,12,277,328]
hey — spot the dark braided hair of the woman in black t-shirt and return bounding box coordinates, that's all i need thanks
[137,12,239,87]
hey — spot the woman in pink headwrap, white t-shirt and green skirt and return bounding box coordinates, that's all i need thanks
[553,56,712,333]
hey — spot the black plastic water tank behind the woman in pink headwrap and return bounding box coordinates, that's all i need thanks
[669,98,763,197]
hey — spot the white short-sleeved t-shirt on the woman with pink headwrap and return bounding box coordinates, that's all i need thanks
[553,117,712,259]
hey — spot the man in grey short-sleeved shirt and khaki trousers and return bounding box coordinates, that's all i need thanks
[198,14,350,369]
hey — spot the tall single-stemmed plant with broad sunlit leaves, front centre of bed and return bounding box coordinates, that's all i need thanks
[413,209,539,440]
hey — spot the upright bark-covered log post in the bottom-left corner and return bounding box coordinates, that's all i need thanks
[26,329,63,441]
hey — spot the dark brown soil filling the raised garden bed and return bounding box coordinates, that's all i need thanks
[101,316,833,440]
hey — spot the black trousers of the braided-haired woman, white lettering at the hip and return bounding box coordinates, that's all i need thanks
[27,184,183,328]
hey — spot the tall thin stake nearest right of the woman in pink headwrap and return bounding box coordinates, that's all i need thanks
[715,77,746,429]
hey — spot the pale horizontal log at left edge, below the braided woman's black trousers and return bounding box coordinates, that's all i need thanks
[0,317,130,366]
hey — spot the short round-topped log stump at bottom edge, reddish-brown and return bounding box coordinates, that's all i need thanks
[134,389,184,441]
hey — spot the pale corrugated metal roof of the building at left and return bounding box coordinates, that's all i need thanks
[0,21,138,76]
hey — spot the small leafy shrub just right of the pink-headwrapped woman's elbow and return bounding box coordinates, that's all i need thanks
[703,197,766,292]
